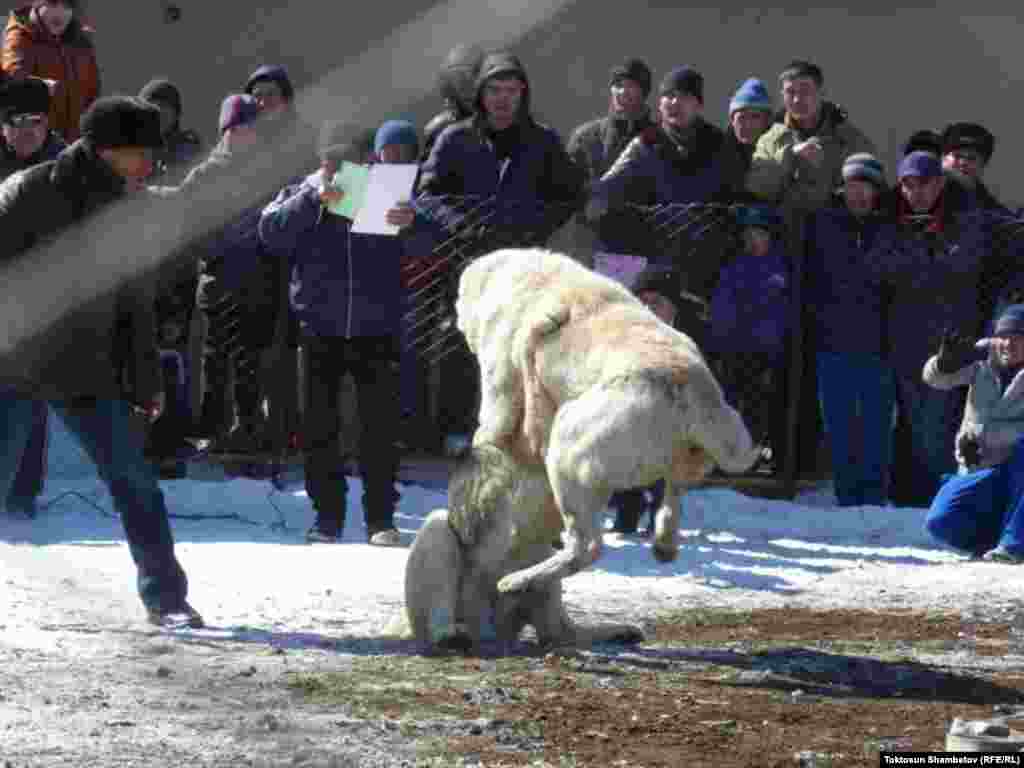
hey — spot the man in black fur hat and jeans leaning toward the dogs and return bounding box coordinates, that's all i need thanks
[0,97,202,627]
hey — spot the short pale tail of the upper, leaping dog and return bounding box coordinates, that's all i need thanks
[687,367,761,473]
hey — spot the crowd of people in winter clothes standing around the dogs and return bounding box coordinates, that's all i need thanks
[0,0,1024,638]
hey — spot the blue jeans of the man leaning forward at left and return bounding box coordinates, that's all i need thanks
[0,398,187,610]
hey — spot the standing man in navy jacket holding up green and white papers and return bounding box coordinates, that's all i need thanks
[260,121,431,546]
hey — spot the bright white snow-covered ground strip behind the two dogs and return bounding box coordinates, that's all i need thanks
[0,411,1024,648]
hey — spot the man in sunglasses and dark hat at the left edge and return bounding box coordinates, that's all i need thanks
[0,78,65,181]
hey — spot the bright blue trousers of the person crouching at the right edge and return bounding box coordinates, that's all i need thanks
[925,440,1024,555]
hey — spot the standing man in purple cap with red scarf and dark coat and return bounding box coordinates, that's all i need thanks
[872,152,1020,506]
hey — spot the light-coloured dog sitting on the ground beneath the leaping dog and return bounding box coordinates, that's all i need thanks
[406,445,643,653]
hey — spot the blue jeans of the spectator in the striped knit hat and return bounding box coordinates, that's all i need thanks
[817,352,896,507]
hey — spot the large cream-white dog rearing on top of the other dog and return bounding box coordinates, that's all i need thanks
[456,249,759,593]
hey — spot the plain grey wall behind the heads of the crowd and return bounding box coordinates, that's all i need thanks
[8,0,1024,204]
